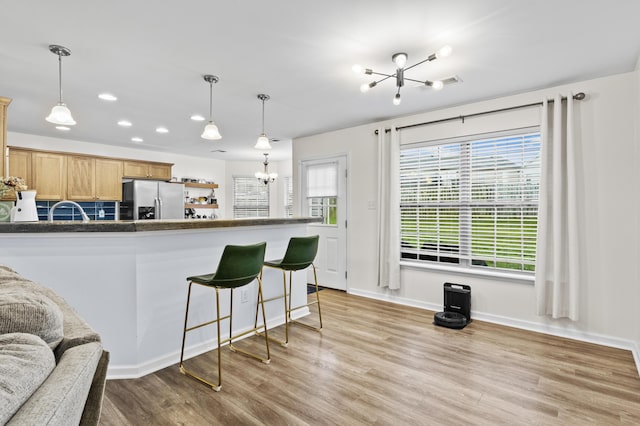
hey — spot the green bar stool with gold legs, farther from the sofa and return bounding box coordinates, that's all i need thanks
[256,235,322,346]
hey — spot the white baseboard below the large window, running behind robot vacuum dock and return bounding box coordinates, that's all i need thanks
[348,289,640,376]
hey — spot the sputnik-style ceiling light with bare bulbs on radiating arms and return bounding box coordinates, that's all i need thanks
[352,46,462,105]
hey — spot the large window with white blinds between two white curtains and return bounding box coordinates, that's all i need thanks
[400,129,541,271]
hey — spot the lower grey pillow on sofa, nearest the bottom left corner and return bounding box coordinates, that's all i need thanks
[0,333,56,425]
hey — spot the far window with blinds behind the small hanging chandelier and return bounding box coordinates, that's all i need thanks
[233,176,269,219]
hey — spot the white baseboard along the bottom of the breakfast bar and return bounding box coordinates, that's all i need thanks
[107,307,311,380]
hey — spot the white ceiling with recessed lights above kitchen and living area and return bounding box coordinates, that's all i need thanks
[0,0,640,160]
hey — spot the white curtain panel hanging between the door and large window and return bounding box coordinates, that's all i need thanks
[378,128,400,290]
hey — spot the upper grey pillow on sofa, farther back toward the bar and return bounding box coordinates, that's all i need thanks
[0,289,63,349]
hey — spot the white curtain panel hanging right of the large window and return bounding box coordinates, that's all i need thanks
[535,93,580,321]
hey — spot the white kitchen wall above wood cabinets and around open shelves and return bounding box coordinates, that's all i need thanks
[7,132,227,217]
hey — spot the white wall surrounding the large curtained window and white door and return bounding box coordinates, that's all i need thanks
[293,73,640,358]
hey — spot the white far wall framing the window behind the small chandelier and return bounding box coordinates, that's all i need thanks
[224,157,291,219]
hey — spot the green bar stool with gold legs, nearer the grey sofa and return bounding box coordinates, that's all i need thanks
[180,242,271,392]
